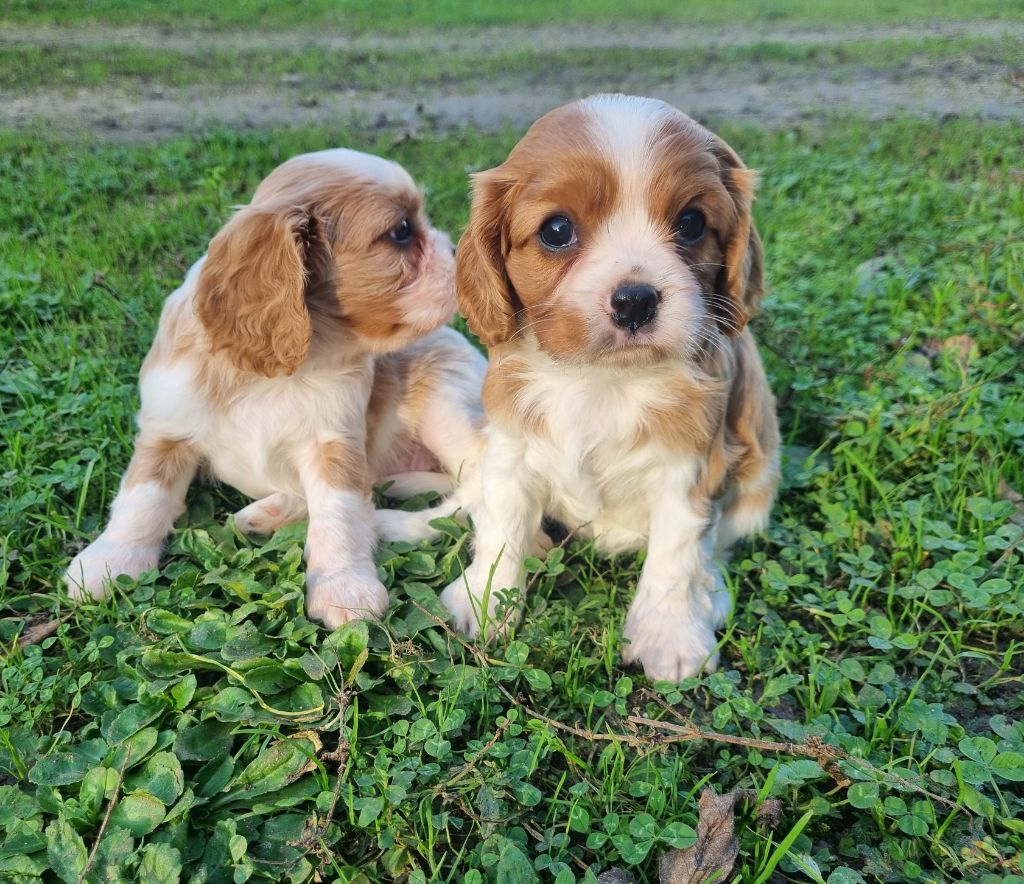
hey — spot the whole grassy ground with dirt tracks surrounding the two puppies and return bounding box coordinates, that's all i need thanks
[0,0,1024,884]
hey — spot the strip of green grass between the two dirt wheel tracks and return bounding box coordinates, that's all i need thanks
[0,37,1024,94]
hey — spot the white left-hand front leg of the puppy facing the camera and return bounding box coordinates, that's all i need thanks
[441,425,543,635]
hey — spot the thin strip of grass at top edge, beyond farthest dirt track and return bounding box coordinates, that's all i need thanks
[0,0,1024,31]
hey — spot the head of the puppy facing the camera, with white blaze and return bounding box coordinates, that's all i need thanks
[457,95,763,362]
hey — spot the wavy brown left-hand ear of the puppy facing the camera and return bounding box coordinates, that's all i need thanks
[455,169,518,347]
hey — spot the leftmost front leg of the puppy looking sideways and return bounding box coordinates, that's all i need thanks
[65,432,199,600]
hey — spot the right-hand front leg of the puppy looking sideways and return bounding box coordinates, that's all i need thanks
[299,436,388,629]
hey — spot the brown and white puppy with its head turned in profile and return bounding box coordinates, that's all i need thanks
[65,150,486,627]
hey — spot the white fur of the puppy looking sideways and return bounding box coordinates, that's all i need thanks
[65,151,486,628]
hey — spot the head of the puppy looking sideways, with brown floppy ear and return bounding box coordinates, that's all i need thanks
[196,150,456,376]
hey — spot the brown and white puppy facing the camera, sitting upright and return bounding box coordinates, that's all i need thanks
[442,95,779,680]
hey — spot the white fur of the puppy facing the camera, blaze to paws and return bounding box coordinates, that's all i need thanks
[441,95,777,680]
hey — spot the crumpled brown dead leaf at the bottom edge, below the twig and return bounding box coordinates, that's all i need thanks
[658,789,782,884]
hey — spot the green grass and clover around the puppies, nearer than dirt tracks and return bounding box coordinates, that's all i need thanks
[0,114,1024,884]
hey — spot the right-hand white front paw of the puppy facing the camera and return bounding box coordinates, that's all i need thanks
[623,590,728,681]
